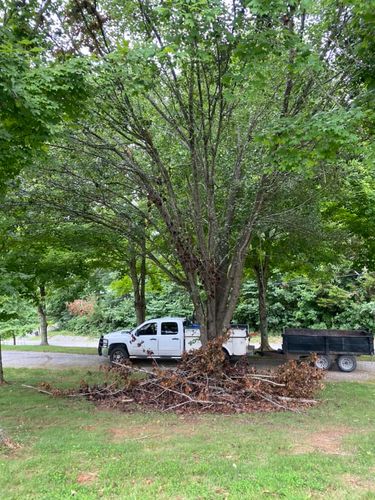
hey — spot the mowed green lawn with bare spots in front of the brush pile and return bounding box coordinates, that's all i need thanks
[0,369,375,500]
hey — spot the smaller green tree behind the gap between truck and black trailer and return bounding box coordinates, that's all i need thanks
[246,171,349,351]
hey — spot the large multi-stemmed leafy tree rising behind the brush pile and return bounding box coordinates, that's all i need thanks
[18,0,374,340]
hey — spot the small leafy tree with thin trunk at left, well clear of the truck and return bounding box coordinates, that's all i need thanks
[0,210,94,345]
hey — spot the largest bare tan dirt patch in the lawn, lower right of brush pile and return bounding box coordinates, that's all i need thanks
[293,427,352,455]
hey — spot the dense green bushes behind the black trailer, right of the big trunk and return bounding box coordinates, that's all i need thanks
[235,269,375,334]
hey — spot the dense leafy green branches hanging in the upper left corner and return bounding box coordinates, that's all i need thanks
[0,0,89,190]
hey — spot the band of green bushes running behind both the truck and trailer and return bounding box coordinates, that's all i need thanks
[49,268,375,336]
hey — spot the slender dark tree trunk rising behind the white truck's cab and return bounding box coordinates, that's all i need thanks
[129,240,146,325]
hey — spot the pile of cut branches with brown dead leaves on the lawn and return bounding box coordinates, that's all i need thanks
[30,338,324,414]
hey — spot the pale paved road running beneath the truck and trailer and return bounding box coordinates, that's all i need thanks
[2,351,375,381]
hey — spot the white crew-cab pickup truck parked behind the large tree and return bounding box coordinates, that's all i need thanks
[98,317,248,363]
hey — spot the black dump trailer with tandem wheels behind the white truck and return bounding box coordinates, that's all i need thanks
[282,328,374,372]
